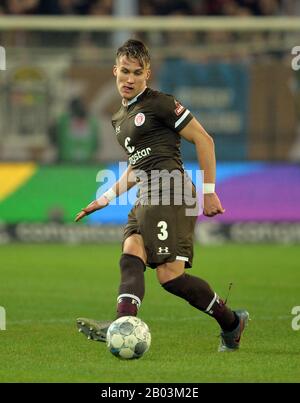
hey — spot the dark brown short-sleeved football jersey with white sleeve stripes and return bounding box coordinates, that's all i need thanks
[112,88,193,204]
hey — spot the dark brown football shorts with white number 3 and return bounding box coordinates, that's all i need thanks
[123,205,197,268]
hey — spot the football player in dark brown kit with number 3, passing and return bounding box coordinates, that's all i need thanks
[75,39,249,351]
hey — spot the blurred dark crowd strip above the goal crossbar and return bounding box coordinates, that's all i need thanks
[0,0,300,16]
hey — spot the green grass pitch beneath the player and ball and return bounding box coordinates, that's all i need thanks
[0,244,300,383]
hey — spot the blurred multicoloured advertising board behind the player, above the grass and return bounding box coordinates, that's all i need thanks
[0,162,300,243]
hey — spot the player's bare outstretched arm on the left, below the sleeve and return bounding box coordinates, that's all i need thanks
[75,165,136,222]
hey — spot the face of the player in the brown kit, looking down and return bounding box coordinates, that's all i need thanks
[113,56,150,100]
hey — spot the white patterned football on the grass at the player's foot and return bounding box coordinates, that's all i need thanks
[106,316,151,359]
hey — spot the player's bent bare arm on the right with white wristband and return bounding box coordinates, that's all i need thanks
[179,118,225,217]
